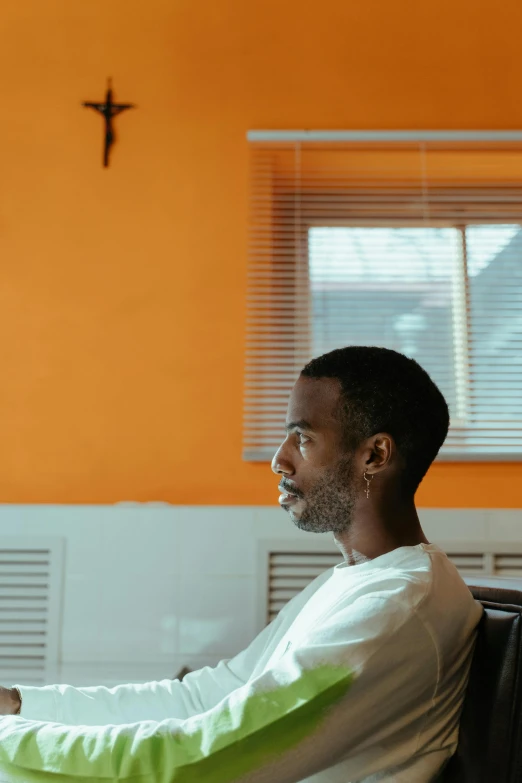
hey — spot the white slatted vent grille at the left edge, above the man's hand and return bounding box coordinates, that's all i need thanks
[0,538,63,685]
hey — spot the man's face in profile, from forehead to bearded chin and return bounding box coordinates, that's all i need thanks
[272,377,362,533]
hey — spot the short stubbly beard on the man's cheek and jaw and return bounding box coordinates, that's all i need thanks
[289,457,356,533]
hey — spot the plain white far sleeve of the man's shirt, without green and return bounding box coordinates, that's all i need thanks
[16,596,292,726]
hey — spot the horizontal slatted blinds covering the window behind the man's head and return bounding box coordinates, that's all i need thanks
[243,138,522,460]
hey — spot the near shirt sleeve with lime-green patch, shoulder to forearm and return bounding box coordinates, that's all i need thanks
[0,596,438,783]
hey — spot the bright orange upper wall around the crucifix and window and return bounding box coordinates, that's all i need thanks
[0,0,522,507]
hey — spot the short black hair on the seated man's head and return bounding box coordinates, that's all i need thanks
[301,345,449,493]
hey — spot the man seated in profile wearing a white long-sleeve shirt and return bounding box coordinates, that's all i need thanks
[0,347,481,783]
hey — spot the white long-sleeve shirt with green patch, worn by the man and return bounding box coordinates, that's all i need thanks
[0,544,482,783]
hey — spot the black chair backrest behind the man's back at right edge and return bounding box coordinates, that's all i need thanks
[441,577,522,783]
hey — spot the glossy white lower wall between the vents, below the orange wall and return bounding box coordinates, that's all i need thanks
[0,503,522,685]
